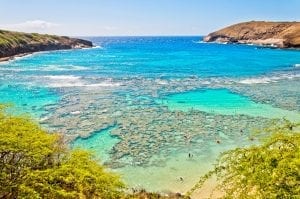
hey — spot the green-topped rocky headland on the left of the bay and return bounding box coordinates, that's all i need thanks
[0,30,93,59]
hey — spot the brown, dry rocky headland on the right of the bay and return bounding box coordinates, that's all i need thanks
[203,21,300,48]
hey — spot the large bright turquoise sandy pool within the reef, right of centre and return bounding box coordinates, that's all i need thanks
[162,89,300,121]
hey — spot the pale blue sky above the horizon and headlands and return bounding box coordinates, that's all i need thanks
[0,0,300,36]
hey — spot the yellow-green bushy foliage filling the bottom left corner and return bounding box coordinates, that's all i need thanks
[0,106,124,199]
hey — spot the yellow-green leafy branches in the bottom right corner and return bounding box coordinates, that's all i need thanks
[187,122,300,199]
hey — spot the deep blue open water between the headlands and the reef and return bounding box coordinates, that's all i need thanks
[4,37,300,78]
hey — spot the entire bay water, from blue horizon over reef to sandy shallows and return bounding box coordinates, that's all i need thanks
[0,37,300,192]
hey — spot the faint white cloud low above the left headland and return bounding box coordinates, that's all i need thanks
[0,20,60,33]
